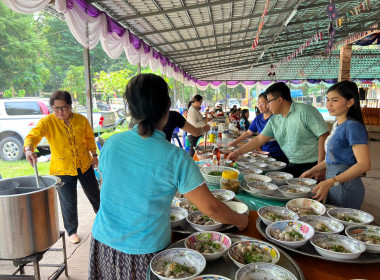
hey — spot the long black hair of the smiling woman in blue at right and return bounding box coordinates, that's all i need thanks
[327,81,364,125]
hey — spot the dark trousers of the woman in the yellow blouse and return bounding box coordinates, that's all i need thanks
[57,166,100,236]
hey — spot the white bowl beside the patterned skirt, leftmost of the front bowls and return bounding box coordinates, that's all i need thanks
[150,248,206,280]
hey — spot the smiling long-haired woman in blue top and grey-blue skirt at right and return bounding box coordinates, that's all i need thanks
[301,81,371,209]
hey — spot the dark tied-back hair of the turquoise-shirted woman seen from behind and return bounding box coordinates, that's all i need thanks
[124,74,171,137]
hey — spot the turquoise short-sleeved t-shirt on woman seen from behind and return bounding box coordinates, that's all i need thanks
[92,126,204,254]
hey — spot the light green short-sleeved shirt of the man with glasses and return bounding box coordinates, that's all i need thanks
[261,101,329,164]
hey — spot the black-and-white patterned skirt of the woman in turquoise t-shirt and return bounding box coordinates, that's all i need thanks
[88,238,155,280]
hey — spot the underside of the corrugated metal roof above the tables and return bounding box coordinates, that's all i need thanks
[46,0,380,80]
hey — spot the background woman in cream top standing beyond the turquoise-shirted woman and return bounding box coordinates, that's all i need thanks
[187,94,211,157]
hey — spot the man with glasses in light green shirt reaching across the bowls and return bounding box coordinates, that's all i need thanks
[228,83,329,179]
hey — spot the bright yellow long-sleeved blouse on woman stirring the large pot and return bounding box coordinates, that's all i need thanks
[24,113,96,176]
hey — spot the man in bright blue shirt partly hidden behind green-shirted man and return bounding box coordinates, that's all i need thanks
[229,93,289,163]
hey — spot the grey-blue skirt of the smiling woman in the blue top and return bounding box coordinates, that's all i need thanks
[326,163,365,209]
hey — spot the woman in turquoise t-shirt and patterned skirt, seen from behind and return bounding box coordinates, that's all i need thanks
[88,74,248,280]
